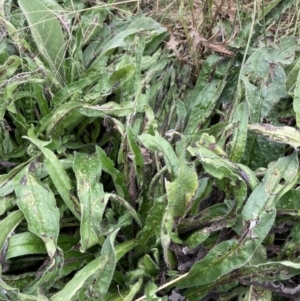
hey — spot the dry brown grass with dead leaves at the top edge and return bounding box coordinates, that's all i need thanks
[140,0,300,72]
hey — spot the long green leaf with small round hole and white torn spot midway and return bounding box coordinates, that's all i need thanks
[176,152,298,288]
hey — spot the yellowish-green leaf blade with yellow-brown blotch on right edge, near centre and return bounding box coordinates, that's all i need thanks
[165,164,198,218]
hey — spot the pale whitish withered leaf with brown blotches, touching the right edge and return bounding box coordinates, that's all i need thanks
[248,123,300,148]
